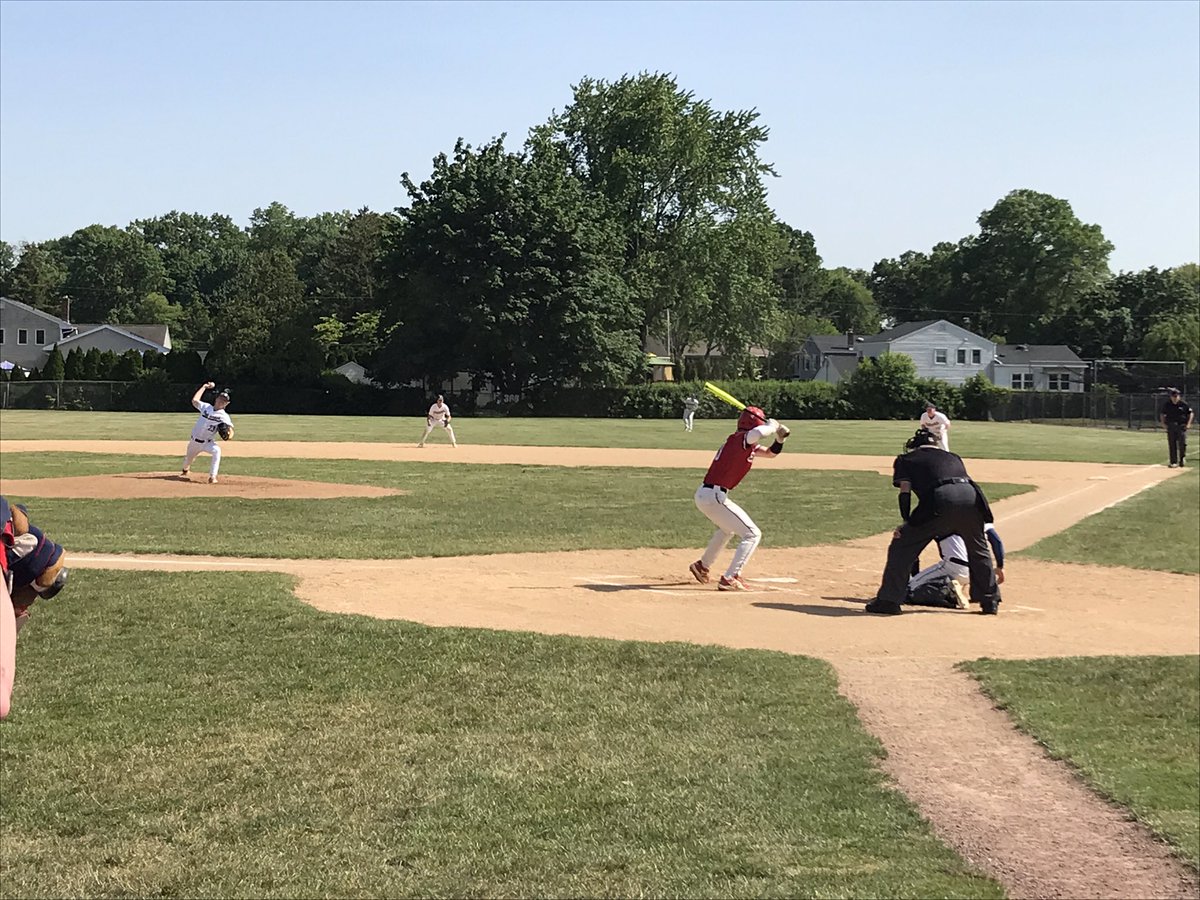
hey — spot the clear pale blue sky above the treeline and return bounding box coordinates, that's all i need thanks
[0,0,1200,270]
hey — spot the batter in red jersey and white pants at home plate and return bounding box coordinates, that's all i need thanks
[688,407,791,590]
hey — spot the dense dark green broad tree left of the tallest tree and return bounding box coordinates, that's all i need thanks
[372,134,640,394]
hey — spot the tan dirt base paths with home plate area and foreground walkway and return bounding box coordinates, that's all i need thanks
[9,442,1200,898]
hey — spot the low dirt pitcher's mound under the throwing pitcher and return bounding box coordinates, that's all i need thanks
[0,472,407,500]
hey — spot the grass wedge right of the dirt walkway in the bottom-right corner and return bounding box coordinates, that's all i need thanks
[962,656,1200,868]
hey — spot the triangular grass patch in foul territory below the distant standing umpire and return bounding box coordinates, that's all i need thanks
[1022,469,1200,575]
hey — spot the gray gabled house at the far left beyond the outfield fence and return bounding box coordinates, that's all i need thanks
[0,296,170,370]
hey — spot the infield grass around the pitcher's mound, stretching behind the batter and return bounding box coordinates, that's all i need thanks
[4,454,1031,559]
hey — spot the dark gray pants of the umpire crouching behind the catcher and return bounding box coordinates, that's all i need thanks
[878,484,1000,605]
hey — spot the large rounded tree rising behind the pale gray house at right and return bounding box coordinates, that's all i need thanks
[961,190,1112,341]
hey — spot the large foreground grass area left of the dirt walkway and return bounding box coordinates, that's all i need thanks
[0,571,1001,898]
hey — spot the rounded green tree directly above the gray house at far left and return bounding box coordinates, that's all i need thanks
[58,226,167,322]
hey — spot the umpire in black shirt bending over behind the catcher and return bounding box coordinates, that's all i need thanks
[866,428,1000,616]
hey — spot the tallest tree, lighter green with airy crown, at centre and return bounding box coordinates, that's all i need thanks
[539,73,774,342]
